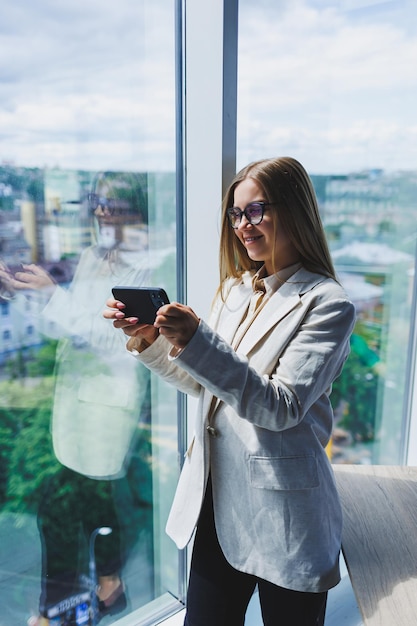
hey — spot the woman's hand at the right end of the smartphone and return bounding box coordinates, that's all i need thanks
[154,302,200,349]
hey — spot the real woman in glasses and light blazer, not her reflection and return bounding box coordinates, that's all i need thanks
[104,157,355,626]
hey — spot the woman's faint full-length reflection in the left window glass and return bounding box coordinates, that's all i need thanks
[0,172,152,626]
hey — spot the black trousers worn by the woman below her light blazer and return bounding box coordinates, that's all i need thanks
[184,481,327,626]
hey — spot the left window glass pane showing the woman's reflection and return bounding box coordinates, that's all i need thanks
[0,0,181,625]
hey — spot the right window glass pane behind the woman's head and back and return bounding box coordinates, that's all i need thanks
[238,0,417,464]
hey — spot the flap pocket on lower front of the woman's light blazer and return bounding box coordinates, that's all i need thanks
[249,455,319,491]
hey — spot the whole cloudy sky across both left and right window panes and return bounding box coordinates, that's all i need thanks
[0,0,417,173]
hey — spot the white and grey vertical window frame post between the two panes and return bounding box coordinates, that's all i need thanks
[175,0,239,601]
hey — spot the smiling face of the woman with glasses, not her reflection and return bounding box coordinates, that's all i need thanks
[233,178,300,274]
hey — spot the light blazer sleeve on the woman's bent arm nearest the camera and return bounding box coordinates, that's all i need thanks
[172,288,355,431]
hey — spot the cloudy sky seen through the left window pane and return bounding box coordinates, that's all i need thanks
[0,0,175,170]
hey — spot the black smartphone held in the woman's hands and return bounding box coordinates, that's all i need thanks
[112,286,169,324]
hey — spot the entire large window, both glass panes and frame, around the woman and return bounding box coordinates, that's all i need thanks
[4,0,417,626]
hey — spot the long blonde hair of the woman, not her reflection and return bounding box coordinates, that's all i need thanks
[219,157,336,289]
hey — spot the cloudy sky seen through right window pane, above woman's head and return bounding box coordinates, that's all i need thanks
[238,0,417,171]
